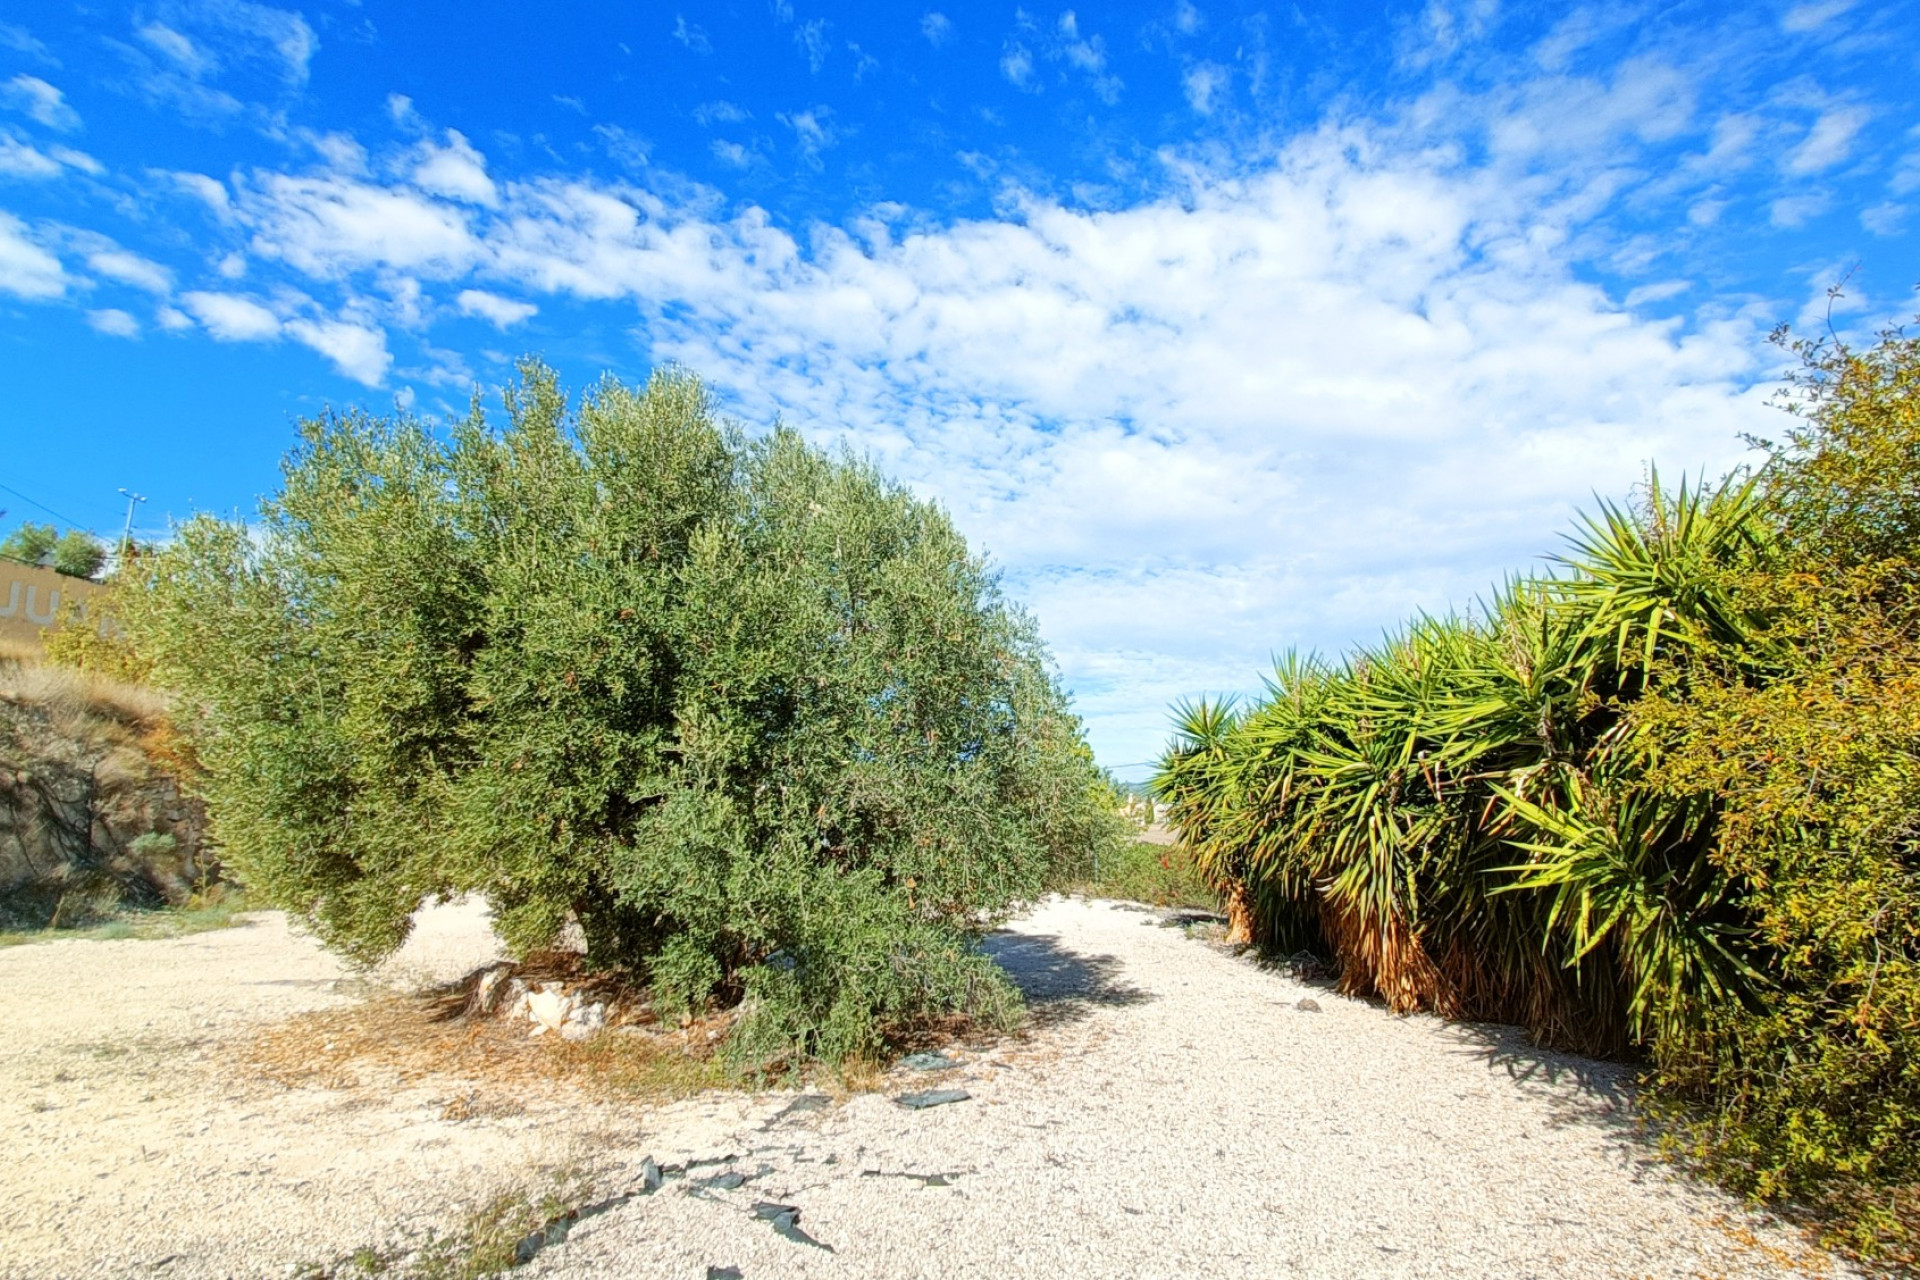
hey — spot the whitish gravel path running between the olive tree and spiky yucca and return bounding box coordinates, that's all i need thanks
[530,900,1841,1280]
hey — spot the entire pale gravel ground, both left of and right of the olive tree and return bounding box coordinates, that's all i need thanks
[0,900,1847,1280]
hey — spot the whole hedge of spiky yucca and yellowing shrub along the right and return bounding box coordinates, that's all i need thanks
[1158,312,1920,1263]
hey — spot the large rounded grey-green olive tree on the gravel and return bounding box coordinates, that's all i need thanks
[125,365,1123,1063]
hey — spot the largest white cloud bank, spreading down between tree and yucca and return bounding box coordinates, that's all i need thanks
[194,113,1764,760]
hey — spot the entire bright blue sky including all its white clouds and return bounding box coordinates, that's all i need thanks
[0,0,1920,777]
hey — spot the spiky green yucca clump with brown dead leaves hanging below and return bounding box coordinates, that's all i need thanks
[1160,460,1766,1050]
